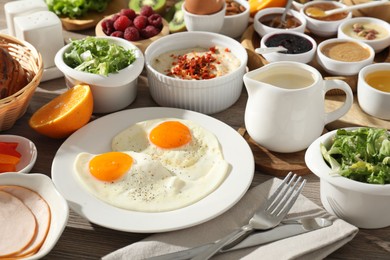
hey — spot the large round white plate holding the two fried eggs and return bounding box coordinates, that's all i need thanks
[52,107,254,233]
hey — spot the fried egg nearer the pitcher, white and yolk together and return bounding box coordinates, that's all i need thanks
[112,118,228,182]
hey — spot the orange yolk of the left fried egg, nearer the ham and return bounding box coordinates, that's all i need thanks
[89,152,133,181]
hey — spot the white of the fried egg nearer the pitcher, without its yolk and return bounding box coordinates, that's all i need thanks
[111,118,228,183]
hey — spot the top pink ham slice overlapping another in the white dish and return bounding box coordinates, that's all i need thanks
[0,191,37,257]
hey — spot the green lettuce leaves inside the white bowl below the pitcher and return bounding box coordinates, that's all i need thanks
[320,127,390,184]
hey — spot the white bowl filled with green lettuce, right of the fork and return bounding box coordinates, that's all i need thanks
[305,127,390,229]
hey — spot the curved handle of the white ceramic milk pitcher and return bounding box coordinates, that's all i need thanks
[324,79,353,125]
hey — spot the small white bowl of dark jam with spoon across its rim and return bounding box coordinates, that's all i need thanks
[260,31,317,63]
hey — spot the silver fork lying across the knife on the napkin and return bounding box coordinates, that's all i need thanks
[192,172,306,260]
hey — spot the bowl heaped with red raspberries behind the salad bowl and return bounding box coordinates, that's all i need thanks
[95,6,169,52]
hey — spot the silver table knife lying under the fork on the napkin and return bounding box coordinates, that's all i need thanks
[148,218,333,260]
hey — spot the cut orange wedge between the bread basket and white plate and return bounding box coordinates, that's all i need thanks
[29,85,93,138]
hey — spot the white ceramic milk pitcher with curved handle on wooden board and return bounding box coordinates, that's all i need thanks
[244,61,353,153]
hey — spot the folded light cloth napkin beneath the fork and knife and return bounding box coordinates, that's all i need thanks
[103,178,358,260]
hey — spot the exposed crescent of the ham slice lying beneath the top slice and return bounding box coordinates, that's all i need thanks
[0,185,51,256]
